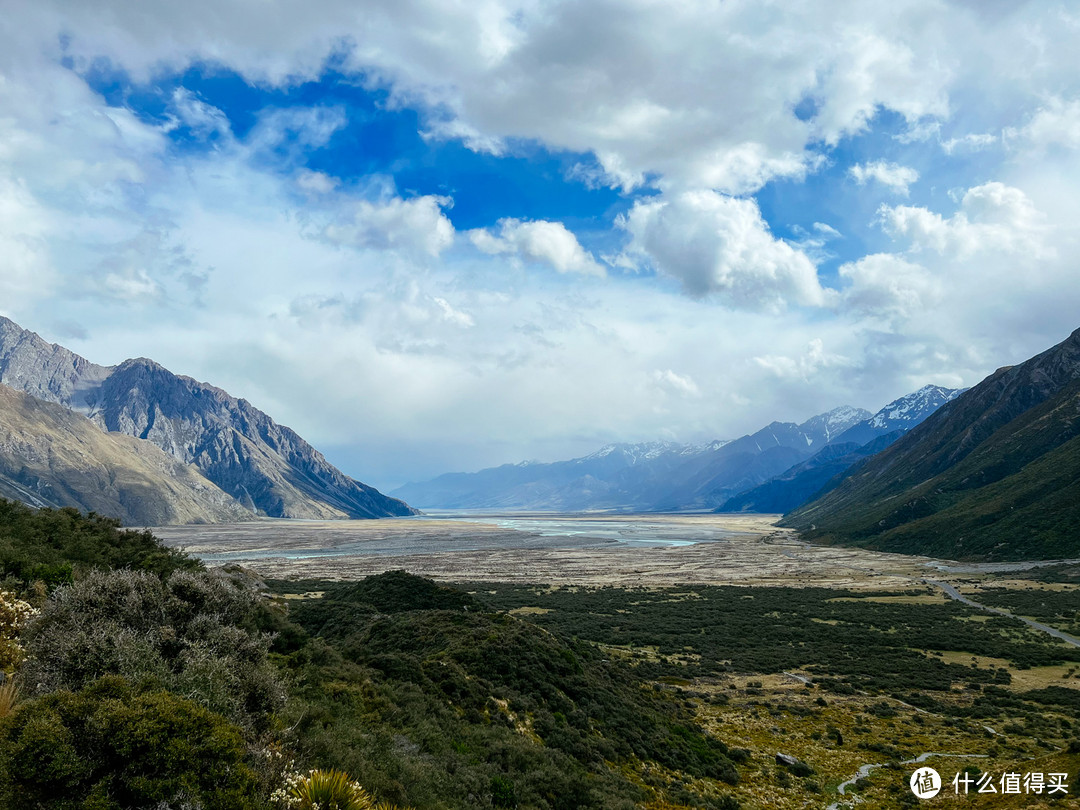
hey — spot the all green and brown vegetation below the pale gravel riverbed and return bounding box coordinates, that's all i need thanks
[0,503,1080,810]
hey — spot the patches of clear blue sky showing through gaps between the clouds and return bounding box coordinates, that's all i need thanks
[84,60,941,280]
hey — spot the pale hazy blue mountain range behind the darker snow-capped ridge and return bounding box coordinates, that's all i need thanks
[392,406,869,511]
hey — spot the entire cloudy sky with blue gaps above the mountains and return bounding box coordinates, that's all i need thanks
[0,0,1080,489]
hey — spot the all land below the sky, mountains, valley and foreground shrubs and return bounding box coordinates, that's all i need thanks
[0,321,1080,810]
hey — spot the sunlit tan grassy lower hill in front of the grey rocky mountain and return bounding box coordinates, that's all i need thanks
[0,384,252,526]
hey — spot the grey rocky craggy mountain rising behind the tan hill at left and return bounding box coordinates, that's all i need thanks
[0,318,415,518]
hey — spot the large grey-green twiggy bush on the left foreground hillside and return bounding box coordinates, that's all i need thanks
[22,571,284,730]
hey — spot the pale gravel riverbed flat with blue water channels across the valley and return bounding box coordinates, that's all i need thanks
[153,513,954,588]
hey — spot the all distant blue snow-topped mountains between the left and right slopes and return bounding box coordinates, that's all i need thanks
[392,386,961,512]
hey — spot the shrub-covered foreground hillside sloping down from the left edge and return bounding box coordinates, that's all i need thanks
[0,502,742,810]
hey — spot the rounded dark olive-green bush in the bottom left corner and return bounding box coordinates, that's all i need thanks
[0,677,262,810]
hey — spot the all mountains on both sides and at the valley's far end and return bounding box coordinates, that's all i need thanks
[0,308,1080,559]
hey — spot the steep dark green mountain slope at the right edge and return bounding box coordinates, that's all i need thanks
[784,329,1080,559]
